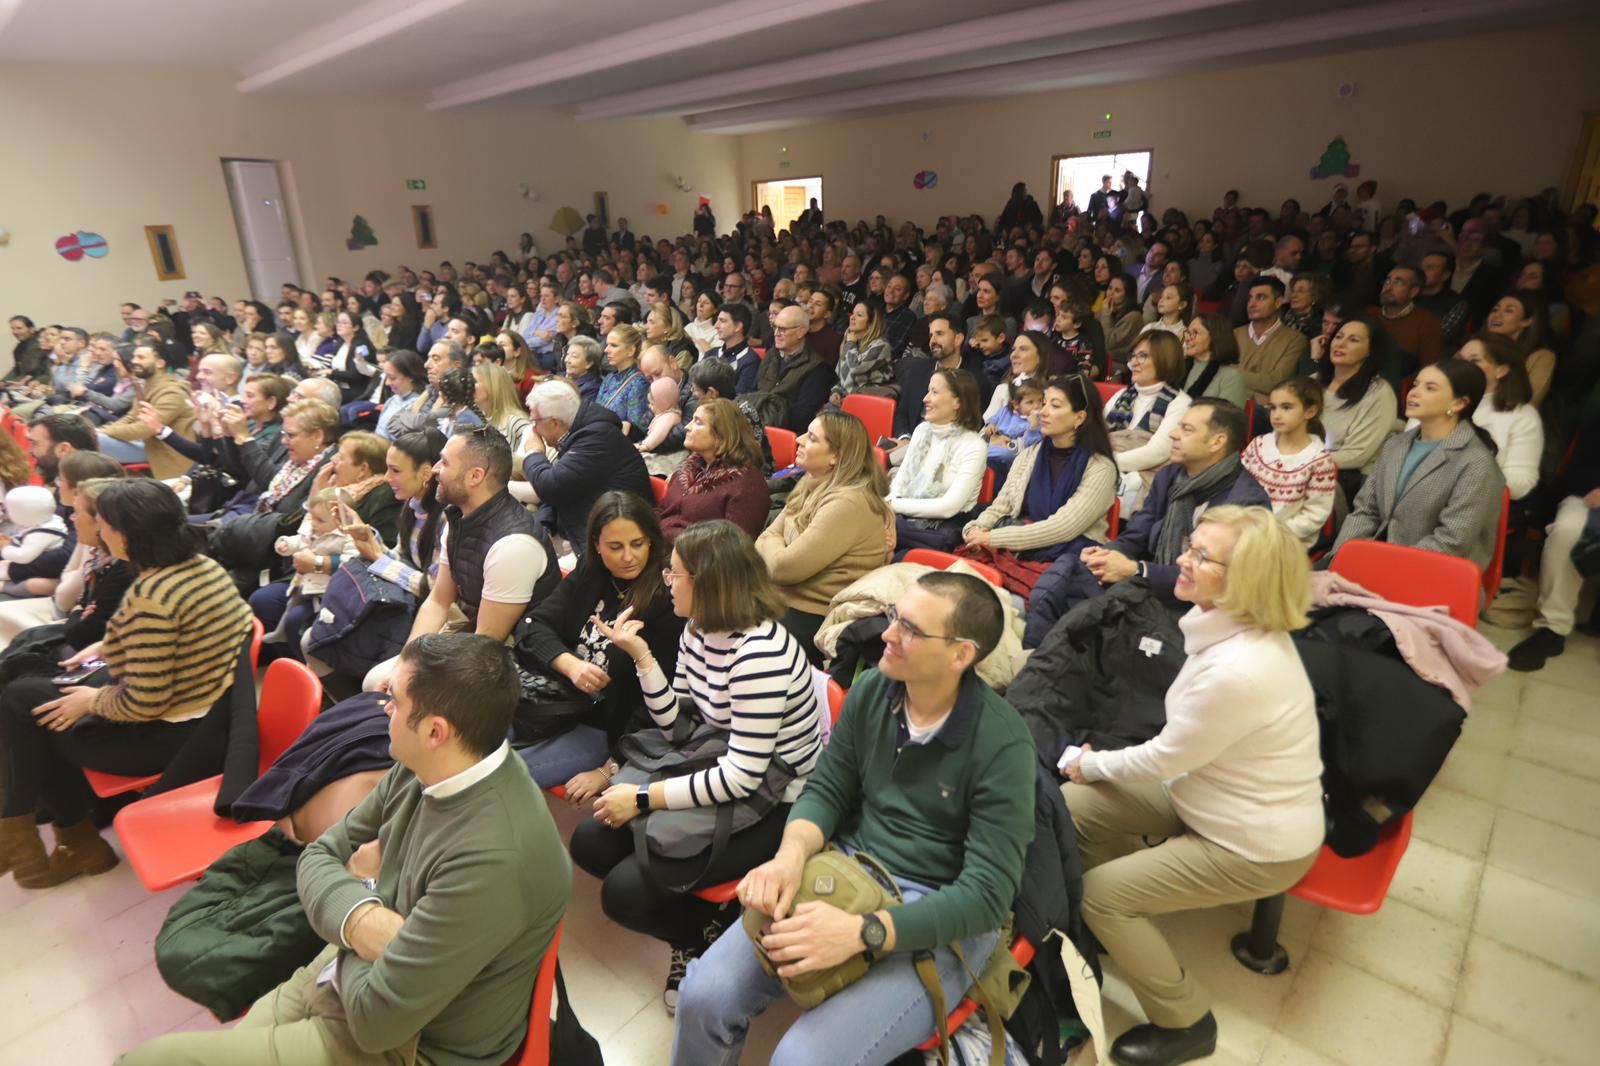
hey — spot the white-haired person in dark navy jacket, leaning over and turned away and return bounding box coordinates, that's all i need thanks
[518,376,654,554]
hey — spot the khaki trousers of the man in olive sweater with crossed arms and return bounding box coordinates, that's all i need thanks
[118,946,418,1066]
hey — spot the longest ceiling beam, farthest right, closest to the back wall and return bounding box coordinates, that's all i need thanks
[688,0,1584,133]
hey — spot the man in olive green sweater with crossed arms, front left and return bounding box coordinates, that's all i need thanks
[122,634,571,1066]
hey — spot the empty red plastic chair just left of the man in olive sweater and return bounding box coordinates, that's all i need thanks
[112,659,322,892]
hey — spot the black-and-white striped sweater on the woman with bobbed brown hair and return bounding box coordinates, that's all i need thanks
[638,621,822,808]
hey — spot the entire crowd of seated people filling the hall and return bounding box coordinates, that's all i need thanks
[0,179,1600,1063]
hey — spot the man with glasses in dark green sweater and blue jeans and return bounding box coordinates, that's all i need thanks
[672,573,1037,1066]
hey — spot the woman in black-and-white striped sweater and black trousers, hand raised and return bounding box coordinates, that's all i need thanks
[571,519,822,1012]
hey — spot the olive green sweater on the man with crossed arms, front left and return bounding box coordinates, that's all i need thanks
[299,751,573,1066]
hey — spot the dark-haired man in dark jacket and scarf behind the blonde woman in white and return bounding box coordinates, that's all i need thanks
[1022,397,1272,648]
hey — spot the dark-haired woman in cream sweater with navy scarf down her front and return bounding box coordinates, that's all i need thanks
[958,375,1117,597]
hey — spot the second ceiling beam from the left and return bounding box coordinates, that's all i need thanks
[427,0,877,110]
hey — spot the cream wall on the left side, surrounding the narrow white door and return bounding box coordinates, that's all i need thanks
[0,64,747,329]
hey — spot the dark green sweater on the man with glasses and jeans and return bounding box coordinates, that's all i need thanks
[789,671,1037,947]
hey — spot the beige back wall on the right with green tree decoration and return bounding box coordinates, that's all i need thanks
[739,22,1600,226]
